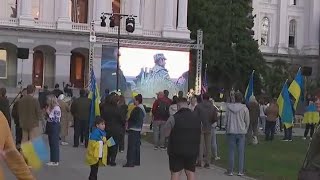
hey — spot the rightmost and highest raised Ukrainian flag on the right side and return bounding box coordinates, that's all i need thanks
[289,68,303,109]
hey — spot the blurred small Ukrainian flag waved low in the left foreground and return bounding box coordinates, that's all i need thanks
[21,137,49,170]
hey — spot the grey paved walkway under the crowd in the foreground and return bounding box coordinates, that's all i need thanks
[0,132,250,180]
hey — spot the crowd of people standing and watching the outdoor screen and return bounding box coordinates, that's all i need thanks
[0,85,319,180]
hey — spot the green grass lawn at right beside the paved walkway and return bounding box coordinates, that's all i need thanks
[143,133,309,180]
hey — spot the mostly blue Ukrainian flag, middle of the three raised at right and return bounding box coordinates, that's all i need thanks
[277,81,293,128]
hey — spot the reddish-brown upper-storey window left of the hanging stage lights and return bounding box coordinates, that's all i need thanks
[70,0,88,23]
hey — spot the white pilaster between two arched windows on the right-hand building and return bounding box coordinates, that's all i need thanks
[278,0,289,54]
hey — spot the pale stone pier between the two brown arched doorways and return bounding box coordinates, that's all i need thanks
[54,52,71,87]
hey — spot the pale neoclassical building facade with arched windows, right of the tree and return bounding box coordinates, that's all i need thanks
[252,0,320,77]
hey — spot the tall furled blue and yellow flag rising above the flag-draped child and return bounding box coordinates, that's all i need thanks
[89,68,100,127]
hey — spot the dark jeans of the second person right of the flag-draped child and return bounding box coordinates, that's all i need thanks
[127,130,141,166]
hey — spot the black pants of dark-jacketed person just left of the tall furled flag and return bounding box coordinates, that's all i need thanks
[73,120,89,147]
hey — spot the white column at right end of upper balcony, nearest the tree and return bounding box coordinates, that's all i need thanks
[177,0,188,31]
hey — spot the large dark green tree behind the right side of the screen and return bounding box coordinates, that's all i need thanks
[188,0,266,93]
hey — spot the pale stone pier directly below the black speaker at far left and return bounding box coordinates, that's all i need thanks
[17,49,33,87]
